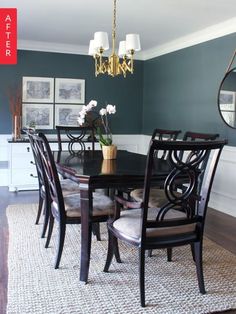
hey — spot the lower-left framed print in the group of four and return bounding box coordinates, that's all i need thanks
[22,104,53,129]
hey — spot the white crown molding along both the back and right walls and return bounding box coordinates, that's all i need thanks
[18,18,236,60]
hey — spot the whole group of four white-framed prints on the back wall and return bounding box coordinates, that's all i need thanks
[22,76,85,129]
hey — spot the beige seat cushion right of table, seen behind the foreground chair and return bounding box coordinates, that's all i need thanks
[130,188,166,207]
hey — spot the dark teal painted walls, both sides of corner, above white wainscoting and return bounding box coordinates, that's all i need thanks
[0,33,236,146]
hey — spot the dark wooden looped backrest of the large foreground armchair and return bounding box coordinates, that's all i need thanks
[142,140,227,240]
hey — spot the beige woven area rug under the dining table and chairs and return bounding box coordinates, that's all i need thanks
[7,204,236,314]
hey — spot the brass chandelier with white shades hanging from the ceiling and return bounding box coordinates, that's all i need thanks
[89,0,141,77]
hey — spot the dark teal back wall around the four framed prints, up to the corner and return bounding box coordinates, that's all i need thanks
[0,51,143,134]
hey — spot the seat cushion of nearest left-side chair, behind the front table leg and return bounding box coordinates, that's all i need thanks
[61,192,114,217]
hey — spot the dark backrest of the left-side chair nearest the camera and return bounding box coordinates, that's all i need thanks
[32,133,66,220]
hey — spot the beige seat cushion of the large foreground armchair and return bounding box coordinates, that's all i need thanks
[113,208,196,241]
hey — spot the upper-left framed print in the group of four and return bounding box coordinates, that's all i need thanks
[22,76,54,103]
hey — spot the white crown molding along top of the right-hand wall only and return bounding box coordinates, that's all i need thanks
[142,18,236,60]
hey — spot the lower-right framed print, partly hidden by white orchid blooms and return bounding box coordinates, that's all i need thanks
[55,104,83,126]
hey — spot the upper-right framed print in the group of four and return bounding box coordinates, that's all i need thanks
[55,78,85,104]
